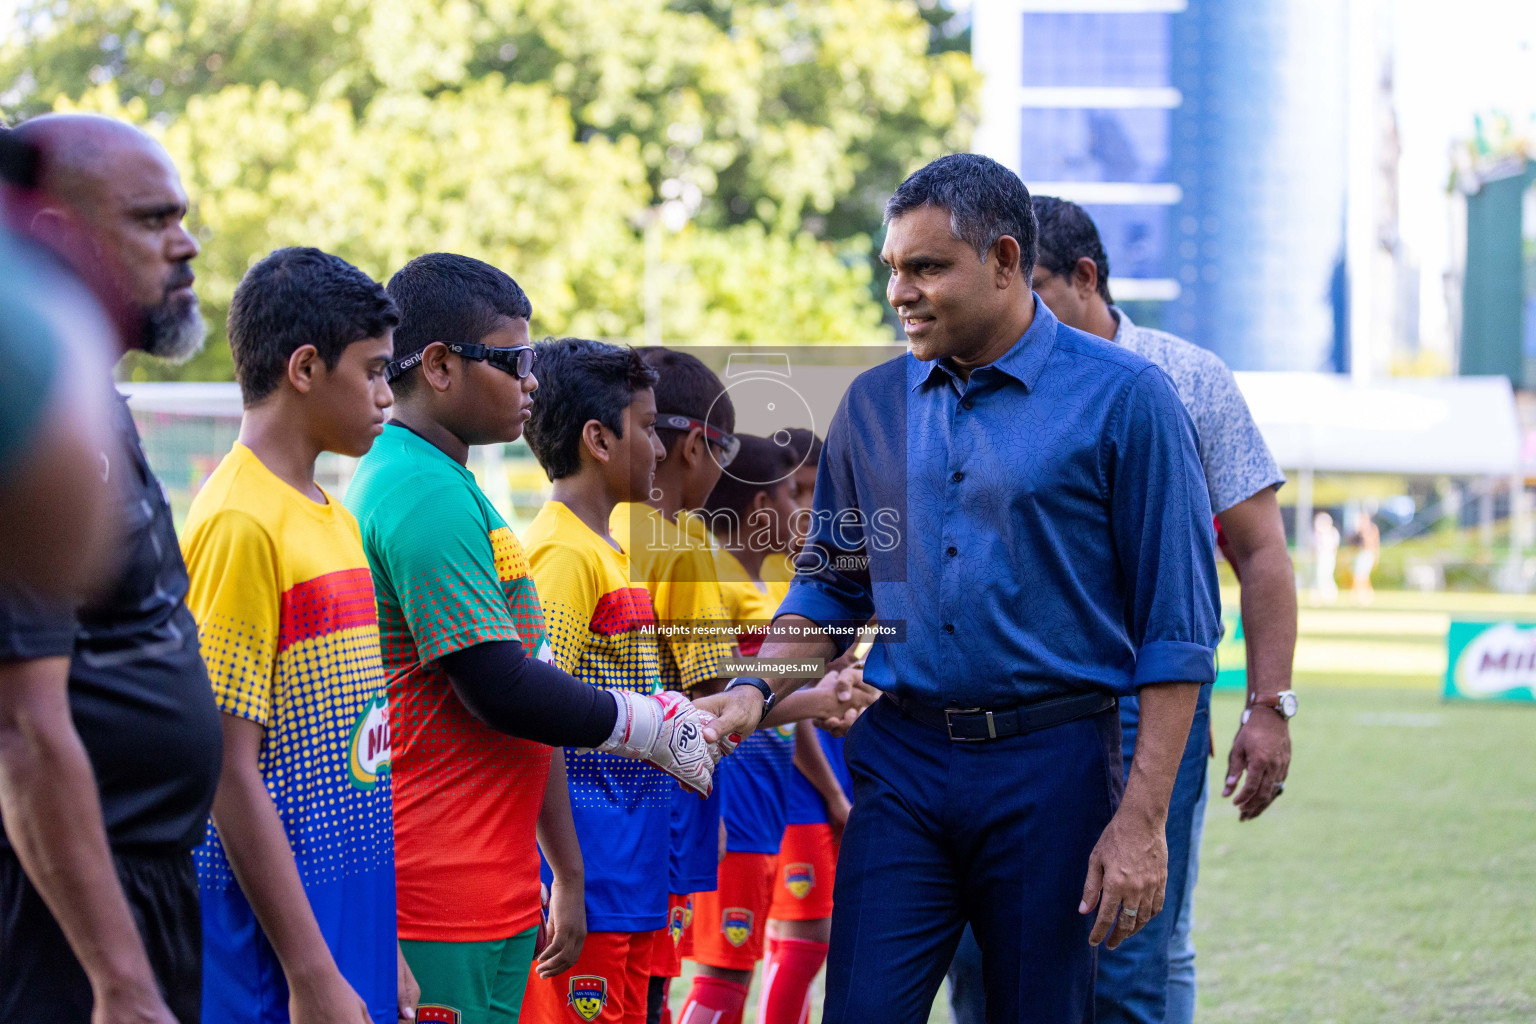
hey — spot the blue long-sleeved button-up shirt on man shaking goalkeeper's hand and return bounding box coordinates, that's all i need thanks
[779,299,1220,706]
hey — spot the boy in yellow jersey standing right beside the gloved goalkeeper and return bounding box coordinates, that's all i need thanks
[525,338,708,1024]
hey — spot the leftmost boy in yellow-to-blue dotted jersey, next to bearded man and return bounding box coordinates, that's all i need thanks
[183,249,416,1024]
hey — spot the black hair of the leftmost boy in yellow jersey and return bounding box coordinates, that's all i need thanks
[226,246,399,405]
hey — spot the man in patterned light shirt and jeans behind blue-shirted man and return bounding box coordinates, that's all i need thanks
[949,195,1296,1024]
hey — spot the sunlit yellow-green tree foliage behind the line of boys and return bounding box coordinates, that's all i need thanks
[0,0,977,376]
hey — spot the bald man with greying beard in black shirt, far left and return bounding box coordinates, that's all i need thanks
[0,114,221,1024]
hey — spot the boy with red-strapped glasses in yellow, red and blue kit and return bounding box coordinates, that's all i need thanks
[611,347,736,1021]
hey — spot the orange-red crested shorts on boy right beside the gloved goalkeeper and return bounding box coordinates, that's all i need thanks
[519,932,651,1024]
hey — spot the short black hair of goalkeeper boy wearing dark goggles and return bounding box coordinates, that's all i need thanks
[386,252,533,395]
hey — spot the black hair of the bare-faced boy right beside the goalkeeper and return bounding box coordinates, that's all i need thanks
[522,338,656,481]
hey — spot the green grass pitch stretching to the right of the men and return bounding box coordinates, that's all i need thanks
[673,593,1536,1024]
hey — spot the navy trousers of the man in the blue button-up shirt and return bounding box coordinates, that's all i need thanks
[822,700,1121,1024]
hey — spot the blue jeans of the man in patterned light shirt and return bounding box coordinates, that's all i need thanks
[949,686,1210,1024]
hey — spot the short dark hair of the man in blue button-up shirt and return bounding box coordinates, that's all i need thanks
[885,154,1037,275]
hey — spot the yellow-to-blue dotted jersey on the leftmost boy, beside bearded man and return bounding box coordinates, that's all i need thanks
[181,444,396,1019]
